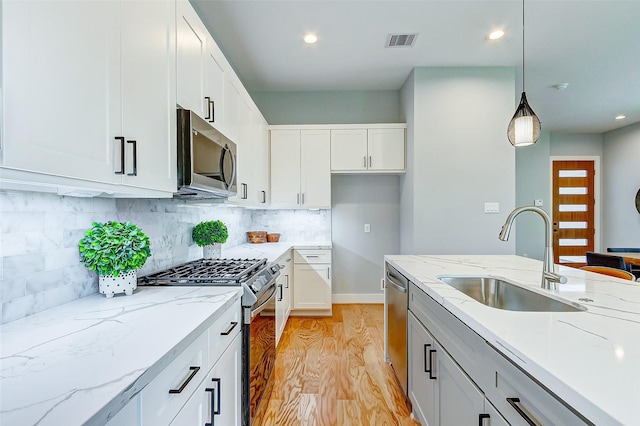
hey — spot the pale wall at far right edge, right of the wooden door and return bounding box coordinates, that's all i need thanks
[602,123,640,248]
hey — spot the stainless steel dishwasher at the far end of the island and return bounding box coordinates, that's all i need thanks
[384,263,409,396]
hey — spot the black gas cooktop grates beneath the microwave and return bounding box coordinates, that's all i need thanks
[138,259,267,285]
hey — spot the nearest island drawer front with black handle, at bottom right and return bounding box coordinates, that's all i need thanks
[483,351,591,426]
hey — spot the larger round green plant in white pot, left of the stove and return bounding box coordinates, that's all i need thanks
[78,221,151,298]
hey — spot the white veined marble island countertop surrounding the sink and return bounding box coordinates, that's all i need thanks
[385,255,640,425]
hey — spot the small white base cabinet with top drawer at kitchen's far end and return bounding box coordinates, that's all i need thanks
[293,249,331,313]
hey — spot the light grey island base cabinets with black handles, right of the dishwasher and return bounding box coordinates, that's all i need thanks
[407,284,589,426]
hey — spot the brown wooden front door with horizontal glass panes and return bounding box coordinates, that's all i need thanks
[552,160,595,267]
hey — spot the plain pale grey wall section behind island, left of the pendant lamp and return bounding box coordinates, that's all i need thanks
[402,67,515,254]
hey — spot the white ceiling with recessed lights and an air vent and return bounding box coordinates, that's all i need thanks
[192,0,640,133]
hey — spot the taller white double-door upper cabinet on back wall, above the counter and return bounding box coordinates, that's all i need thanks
[271,129,331,208]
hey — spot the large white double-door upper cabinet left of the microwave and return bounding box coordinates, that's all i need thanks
[2,1,176,197]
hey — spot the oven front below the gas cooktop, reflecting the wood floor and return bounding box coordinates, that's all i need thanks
[249,280,277,424]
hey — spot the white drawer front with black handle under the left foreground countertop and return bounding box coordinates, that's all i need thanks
[140,331,209,425]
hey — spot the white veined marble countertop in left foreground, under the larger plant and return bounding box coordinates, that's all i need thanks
[0,287,242,426]
